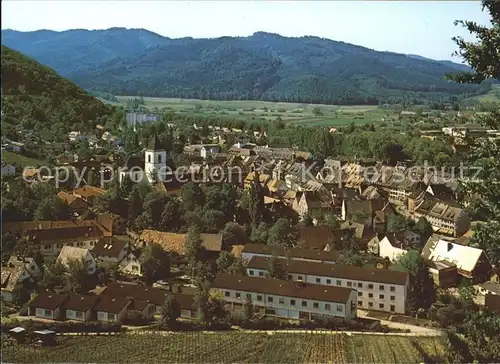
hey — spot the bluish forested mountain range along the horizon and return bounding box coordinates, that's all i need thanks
[2,28,487,104]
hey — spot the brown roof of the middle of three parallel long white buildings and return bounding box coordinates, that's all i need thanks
[247,257,408,285]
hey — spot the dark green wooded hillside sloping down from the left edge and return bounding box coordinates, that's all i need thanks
[1,46,113,136]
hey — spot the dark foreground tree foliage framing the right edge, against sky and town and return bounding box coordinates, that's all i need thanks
[448,1,500,268]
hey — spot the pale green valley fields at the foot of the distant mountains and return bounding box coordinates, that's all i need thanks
[117,96,391,126]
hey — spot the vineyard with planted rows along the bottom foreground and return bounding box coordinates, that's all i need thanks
[2,332,443,363]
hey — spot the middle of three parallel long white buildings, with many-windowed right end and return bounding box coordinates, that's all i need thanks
[246,257,409,314]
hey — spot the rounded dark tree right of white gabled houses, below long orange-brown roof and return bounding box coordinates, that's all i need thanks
[140,243,170,283]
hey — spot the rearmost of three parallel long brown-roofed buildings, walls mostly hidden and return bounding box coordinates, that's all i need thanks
[241,244,340,264]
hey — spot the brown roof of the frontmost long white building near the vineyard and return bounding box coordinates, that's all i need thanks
[212,274,353,303]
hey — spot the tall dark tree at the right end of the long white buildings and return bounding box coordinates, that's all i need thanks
[395,249,436,311]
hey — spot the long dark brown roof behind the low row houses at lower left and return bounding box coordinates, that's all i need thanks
[101,283,194,310]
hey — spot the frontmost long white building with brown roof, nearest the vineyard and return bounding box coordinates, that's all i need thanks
[211,274,356,320]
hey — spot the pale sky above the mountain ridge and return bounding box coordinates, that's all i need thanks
[1,0,489,62]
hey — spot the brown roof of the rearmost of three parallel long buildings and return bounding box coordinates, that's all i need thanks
[243,244,340,262]
